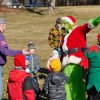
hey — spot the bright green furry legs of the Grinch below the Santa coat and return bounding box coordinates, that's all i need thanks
[64,63,86,100]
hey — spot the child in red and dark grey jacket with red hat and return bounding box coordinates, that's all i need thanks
[8,54,35,100]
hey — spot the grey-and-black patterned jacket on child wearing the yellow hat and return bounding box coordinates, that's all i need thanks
[43,72,67,100]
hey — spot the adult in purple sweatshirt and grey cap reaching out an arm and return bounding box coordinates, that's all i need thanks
[0,18,29,100]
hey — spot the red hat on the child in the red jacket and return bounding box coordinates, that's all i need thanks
[14,54,27,69]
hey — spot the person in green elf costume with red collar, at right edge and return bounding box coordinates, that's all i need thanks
[85,33,100,100]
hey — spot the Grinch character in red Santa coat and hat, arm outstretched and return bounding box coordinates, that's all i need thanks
[61,16,100,100]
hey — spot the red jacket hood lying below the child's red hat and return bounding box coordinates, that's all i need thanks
[9,70,30,82]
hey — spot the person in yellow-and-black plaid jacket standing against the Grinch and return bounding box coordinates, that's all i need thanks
[48,18,65,58]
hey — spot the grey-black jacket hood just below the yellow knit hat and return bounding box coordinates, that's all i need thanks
[50,73,67,86]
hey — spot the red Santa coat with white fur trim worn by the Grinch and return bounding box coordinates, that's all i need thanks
[62,23,91,66]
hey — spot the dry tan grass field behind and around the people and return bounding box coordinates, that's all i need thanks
[0,6,100,98]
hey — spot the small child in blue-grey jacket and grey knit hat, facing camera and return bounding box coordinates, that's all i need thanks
[26,42,41,100]
